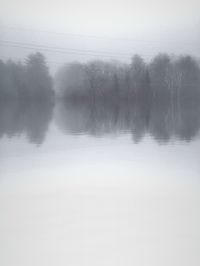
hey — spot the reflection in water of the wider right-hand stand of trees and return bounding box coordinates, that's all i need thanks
[56,96,200,143]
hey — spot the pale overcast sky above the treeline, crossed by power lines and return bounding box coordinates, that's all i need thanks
[0,0,200,68]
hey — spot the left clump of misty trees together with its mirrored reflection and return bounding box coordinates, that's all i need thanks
[0,53,55,144]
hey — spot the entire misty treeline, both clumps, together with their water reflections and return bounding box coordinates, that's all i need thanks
[0,53,200,144]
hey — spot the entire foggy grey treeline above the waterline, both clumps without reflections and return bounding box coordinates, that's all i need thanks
[0,53,200,106]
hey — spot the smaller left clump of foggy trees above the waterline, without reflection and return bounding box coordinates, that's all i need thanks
[0,53,54,101]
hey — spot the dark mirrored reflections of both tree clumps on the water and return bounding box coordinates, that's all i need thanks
[0,97,200,144]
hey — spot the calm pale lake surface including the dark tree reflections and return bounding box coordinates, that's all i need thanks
[0,103,200,266]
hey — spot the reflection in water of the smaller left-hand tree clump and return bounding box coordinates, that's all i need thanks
[0,100,53,145]
